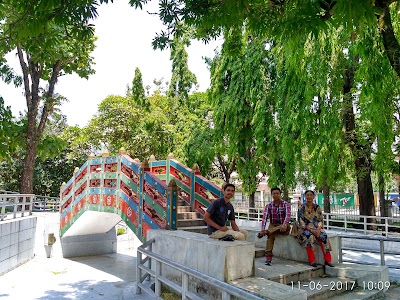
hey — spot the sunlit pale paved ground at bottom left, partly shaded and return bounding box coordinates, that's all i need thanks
[0,253,146,300]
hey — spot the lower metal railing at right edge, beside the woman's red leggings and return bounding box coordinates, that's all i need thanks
[338,234,400,269]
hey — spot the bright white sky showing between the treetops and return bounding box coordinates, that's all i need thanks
[0,0,221,127]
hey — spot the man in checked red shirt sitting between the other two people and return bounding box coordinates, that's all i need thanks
[260,187,290,266]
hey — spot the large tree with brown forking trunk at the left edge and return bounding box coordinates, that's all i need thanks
[0,0,96,193]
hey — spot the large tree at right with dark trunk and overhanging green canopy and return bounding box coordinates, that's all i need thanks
[148,0,400,215]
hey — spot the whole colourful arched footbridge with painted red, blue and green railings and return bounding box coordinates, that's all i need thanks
[60,150,222,241]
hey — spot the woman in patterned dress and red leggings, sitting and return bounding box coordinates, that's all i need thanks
[298,190,333,267]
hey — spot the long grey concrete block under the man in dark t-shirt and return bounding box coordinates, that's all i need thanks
[148,230,255,281]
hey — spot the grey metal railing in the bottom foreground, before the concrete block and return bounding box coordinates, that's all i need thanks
[136,239,263,300]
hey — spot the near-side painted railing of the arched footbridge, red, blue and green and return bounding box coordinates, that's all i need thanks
[60,153,177,241]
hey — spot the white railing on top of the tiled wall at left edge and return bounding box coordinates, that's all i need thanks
[0,194,35,221]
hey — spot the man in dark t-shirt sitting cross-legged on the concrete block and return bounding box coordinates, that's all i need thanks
[204,183,247,241]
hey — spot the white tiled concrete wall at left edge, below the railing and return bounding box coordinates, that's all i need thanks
[0,216,37,275]
